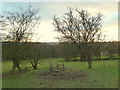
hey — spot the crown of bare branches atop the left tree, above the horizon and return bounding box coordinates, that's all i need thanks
[1,6,40,42]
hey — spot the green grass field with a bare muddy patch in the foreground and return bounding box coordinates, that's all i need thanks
[2,59,118,88]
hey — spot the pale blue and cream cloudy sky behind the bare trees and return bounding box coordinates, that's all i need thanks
[0,2,118,42]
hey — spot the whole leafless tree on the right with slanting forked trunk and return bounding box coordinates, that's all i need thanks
[53,8,102,69]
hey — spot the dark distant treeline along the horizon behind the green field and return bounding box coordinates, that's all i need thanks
[2,42,120,60]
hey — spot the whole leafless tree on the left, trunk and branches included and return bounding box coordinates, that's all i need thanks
[1,6,40,70]
